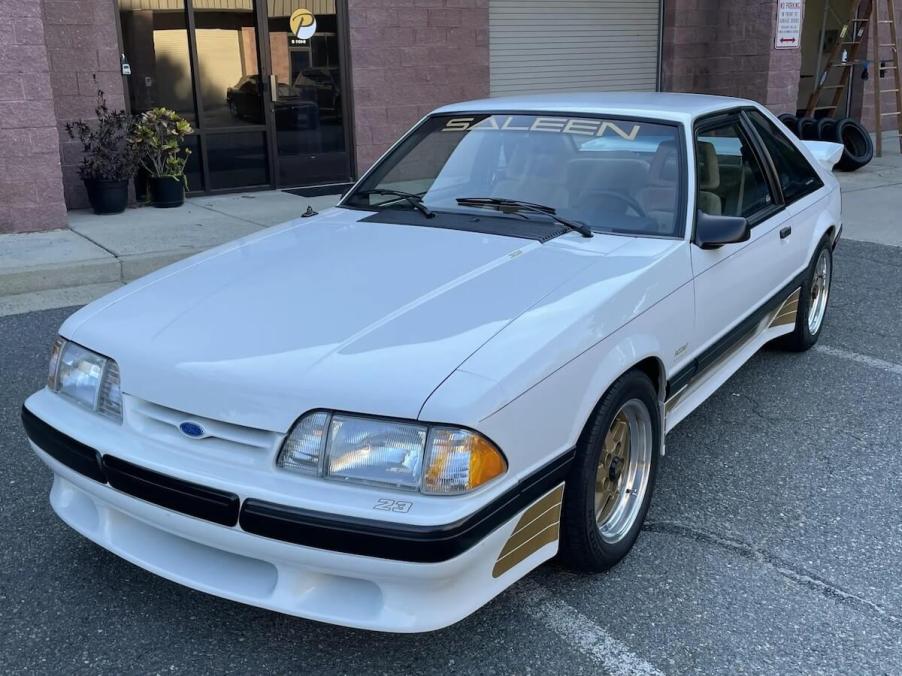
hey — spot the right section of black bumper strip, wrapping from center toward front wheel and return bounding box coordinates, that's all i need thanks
[239,450,575,563]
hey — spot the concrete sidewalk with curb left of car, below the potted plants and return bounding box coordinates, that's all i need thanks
[0,190,339,316]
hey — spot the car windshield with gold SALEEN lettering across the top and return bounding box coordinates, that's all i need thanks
[343,114,681,236]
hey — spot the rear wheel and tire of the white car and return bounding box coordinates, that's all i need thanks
[774,235,833,352]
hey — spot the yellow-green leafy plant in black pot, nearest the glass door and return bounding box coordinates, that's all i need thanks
[132,108,194,208]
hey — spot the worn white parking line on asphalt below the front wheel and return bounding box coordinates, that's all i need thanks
[512,578,663,676]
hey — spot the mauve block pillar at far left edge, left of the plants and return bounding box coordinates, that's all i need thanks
[0,0,66,233]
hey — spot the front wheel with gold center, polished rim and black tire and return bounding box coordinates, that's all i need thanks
[559,370,662,572]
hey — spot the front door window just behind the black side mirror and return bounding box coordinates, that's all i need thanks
[695,120,773,218]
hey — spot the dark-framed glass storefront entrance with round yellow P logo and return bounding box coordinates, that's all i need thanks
[119,0,351,192]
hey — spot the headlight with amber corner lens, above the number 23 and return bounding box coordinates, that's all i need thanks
[277,411,507,495]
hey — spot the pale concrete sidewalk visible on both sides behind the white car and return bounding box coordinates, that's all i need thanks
[0,140,902,316]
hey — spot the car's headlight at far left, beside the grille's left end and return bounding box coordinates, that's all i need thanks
[47,338,122,422]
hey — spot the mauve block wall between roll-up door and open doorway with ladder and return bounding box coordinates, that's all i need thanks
[662,0,801,113]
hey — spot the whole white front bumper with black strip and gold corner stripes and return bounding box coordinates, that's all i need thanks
[23,409,569,632]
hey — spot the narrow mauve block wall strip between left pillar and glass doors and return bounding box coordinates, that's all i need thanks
[43,0,125,209]
